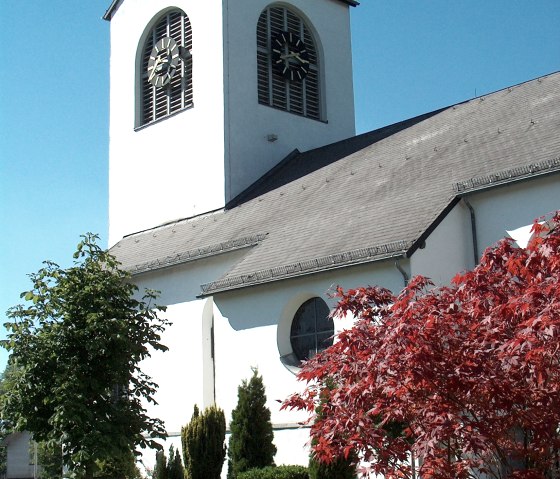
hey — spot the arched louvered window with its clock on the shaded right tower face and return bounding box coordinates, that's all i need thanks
[257,6,322,120]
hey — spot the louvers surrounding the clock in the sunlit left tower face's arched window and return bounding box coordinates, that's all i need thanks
[139,10,193,126]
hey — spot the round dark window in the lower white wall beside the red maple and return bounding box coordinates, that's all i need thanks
[290,298,334,361]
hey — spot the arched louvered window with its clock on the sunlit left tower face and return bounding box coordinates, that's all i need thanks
[138,10,193,126]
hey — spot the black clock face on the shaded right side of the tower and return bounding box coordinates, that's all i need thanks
[270,32,309,81]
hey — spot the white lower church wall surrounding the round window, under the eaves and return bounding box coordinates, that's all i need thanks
[214,261,407,465]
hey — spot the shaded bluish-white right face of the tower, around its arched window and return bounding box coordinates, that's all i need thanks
[224,0,355,199]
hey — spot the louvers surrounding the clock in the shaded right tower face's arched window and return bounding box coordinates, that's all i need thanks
[257,6,322,120]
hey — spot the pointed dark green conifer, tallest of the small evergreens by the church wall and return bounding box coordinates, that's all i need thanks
[228,369,276,479]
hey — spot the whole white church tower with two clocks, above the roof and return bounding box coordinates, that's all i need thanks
[104,0,357,245]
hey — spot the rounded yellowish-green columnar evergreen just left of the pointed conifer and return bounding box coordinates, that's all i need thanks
[181,405,226,479]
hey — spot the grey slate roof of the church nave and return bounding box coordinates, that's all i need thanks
[112,73,560,295]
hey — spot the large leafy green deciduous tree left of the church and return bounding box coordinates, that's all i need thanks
[1,234,168,478]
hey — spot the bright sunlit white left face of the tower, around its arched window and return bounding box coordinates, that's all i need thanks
[109,0,224,245]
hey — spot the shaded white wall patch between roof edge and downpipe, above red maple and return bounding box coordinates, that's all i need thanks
[410,202,474,286]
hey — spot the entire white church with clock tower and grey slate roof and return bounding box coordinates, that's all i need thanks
[104,0,560,472]
